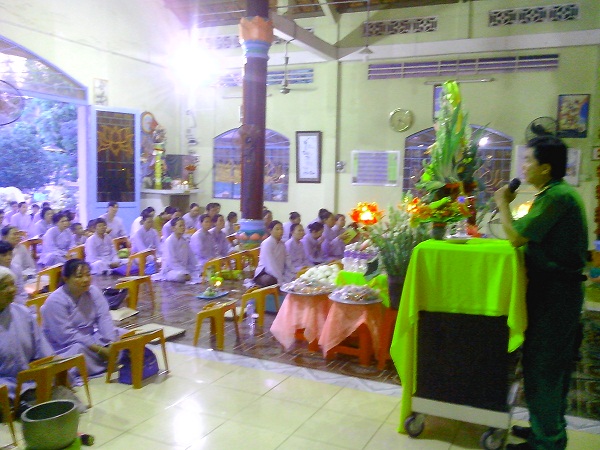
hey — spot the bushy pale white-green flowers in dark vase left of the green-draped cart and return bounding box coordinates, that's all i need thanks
[367,195,429,279]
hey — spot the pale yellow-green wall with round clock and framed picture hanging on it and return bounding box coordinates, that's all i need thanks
[0,0,600,243]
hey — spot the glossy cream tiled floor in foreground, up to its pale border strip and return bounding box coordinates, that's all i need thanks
[0,343,600,450]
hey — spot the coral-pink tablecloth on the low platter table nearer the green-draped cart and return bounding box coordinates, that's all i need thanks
[319,300,383,355]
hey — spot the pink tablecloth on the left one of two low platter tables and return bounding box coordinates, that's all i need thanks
[271,294,331,350]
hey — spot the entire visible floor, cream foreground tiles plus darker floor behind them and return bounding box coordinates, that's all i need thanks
[0,277,600,450]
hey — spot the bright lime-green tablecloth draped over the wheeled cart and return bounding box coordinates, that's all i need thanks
[390,239,527,433]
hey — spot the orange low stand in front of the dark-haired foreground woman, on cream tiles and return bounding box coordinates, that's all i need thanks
[106,328,169,389]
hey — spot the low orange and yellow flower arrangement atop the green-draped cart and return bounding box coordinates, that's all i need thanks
[406,196,471,224]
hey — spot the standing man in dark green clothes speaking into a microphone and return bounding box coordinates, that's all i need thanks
[494,136,588,450]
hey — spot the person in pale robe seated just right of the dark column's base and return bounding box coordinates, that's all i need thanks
[254,220,294,286]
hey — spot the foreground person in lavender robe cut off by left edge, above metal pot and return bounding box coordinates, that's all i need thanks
[0,267,53,399]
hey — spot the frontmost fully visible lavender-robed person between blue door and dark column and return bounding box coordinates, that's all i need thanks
[161,217,198,283]
